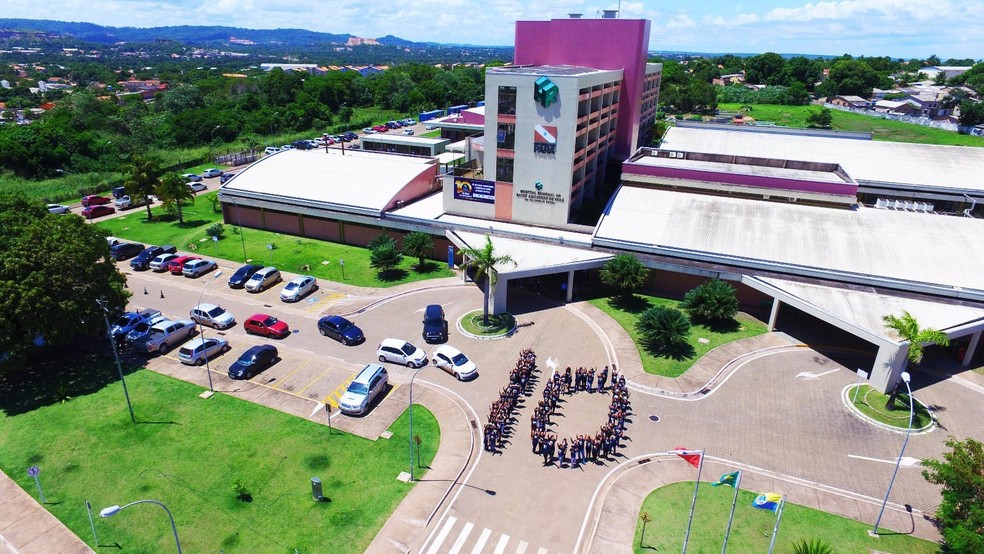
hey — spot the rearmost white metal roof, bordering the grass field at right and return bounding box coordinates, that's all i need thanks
[660,127,984,193]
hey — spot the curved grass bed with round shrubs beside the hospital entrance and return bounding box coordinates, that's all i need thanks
[590,294,766,377]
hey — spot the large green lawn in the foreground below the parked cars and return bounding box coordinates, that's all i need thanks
[0,356,440,553]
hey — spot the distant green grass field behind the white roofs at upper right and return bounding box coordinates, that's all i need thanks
[718,104,984,147]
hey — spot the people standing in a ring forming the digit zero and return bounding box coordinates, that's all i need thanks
[530,366,631,468]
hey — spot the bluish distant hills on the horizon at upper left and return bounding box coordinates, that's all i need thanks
[0,19,396,46]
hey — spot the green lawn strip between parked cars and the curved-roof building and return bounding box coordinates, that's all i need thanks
[98,192,454,287]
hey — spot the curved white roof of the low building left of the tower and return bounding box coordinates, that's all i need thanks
[223,149,435,210]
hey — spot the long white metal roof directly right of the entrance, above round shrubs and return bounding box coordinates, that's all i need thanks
[595,186,984,296]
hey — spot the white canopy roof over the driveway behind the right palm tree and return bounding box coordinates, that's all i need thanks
[756,277,984,342]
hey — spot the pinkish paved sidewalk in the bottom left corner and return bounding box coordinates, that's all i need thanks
[0,471,93,554]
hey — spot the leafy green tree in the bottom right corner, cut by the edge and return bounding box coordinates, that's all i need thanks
[922,437,984,554]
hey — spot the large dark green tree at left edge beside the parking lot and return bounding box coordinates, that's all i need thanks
[0,195,129,371]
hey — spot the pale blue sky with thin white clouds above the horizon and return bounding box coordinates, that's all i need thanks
[0,0,984,60]
